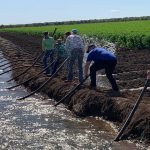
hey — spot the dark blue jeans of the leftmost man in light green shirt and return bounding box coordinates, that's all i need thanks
[43,50,53,74]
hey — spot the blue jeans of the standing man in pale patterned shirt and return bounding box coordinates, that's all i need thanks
[67,49,84,82]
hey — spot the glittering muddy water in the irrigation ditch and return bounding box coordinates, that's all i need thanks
[0,54,144,150]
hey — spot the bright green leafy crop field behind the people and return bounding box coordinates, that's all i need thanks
[0,20,150,49]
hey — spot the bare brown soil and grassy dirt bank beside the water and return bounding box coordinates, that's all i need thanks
[0,33,150,144]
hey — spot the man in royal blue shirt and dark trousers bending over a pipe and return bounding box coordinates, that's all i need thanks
[84,44,119,91]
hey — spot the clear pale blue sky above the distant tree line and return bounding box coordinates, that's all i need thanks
[0,0,150,25]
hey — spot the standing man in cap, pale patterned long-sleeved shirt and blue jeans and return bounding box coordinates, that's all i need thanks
[65,29,84,82]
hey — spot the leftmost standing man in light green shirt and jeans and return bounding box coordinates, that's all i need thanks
[42,32,55,75]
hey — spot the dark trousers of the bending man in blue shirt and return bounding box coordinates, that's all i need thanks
[90,60,118,91]
